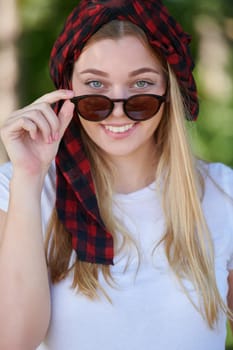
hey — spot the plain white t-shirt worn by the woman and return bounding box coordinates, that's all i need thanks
[0,163,233,350]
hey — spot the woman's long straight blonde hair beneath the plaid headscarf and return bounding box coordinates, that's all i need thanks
[46,21,232,327]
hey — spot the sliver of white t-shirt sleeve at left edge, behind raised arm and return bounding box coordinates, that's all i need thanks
[0,163,12,212]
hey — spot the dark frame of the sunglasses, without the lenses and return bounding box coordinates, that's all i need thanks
[70,90,167,122]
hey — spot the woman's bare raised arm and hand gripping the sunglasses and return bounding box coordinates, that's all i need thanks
[0,90,73,350]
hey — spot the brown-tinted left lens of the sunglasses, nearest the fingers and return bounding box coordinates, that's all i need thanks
[77,96,111,121]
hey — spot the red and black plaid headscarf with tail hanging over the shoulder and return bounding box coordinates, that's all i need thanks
[50,0,198,264]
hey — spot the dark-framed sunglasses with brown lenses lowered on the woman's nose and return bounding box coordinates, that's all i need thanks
[70,93,167,122]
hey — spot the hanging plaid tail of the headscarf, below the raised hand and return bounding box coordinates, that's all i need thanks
[56,118,113,264]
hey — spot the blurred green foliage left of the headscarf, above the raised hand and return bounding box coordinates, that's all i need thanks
[18,0,77,104]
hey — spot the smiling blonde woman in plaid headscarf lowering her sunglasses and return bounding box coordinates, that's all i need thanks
[0,0,233,350]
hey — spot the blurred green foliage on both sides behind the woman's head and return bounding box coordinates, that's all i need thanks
[17,0,233,166]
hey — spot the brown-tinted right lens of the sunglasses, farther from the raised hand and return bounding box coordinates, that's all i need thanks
[125,95,160,121]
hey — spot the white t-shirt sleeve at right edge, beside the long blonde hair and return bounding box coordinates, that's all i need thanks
[206,163,233,270]
